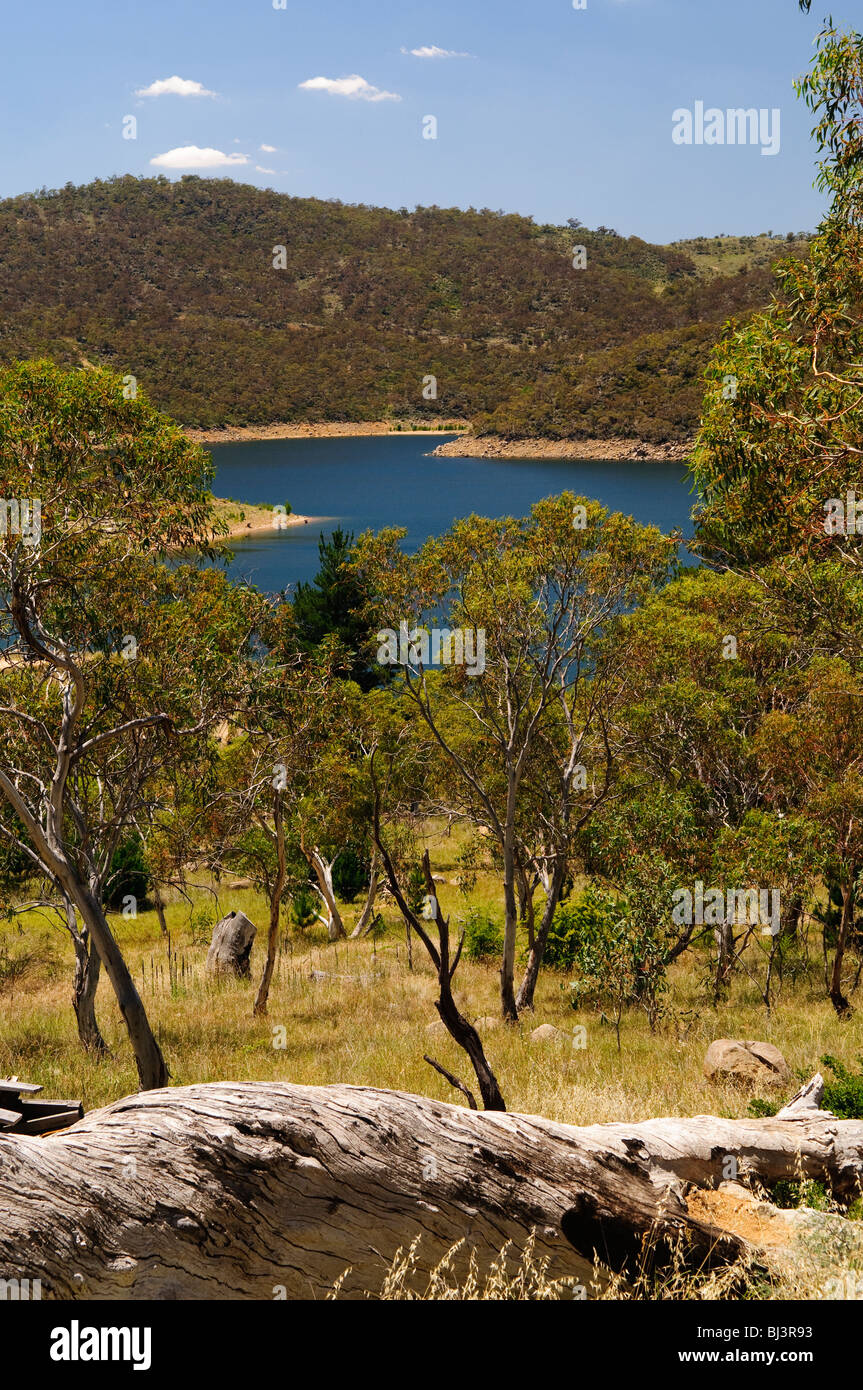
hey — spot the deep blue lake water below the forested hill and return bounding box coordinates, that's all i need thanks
[210,435,693,591]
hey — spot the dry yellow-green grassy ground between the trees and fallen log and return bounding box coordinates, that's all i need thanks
[0,811,863,1125]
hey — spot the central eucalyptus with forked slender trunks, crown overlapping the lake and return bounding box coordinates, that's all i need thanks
[356,493,675,1022]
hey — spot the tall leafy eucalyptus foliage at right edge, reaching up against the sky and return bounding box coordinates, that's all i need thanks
[693,22,863,566]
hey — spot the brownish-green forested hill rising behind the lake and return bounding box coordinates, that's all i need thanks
[0,177,798,442]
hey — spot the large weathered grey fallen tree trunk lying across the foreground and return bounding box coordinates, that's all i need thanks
[0,1083,863,1300]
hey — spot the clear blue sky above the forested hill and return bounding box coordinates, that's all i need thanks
[0,0,860,242]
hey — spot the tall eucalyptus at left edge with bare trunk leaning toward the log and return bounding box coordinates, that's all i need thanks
[0,361,255,1088]
